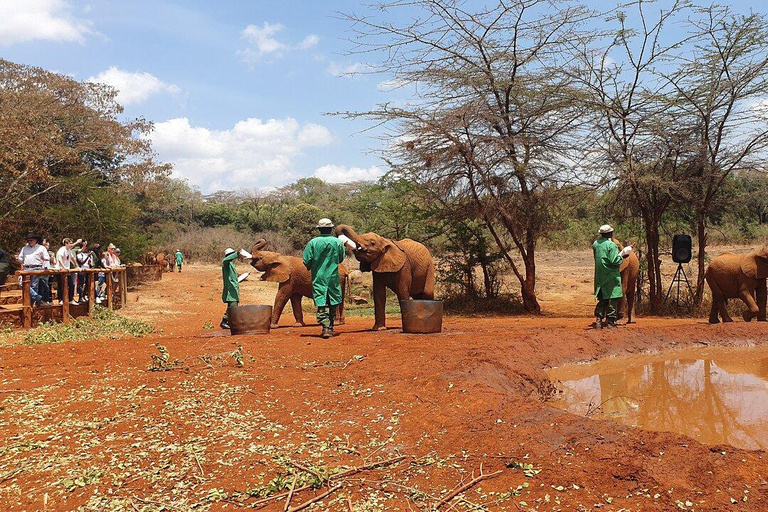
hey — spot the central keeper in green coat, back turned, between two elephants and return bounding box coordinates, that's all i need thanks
[303,219,346,339]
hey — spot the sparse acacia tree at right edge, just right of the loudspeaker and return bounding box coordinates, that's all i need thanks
[660,5,768,304]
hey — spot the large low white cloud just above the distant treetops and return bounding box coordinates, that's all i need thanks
[151,118,334,192]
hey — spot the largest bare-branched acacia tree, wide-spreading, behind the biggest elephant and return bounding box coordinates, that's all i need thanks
[346,0,592,313]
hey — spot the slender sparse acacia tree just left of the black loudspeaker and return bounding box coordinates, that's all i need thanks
[569,1,693,312]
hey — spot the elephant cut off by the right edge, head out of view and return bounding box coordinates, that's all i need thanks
[704,246,768,324]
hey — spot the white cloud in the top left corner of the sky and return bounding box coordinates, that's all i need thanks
[0,0,95,46]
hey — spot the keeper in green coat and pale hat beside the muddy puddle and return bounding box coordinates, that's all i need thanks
[592,224,634,329]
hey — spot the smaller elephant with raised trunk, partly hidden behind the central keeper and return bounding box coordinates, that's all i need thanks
[251,238,349,328]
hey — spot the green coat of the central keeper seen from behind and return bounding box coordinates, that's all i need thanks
[303,234,346,306]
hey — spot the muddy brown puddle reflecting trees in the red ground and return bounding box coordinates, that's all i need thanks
[547,347,768,450]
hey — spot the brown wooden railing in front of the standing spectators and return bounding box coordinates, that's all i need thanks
[16,267,128,328]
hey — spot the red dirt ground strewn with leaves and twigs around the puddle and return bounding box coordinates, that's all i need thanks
[0,266,768,511]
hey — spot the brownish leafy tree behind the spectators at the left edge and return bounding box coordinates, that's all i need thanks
[0,59,170,251]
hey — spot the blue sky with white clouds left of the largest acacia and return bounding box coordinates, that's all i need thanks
[0,0,765,193]
